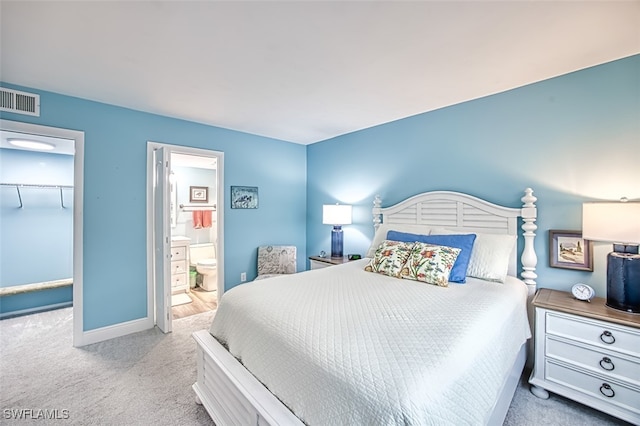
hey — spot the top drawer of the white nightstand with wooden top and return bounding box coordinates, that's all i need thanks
[546,312,640,357]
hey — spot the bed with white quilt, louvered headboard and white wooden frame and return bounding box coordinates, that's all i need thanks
[193,189,537,426]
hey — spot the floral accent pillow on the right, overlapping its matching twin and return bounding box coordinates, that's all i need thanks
[401,243,461,287]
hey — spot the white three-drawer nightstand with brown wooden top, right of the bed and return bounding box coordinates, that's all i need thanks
[529,289,640,424]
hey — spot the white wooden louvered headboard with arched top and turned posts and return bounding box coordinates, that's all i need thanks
[373,188,538,295]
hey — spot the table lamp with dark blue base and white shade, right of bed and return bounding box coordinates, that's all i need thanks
[582,198,640,313]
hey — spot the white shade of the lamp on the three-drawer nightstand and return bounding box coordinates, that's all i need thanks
[582,202,640,243]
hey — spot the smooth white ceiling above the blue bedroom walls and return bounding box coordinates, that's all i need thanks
[0,0,640,144]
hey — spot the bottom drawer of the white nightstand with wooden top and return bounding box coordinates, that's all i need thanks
[545,361,640,415]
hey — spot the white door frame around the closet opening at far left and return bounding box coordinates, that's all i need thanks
[0,119,86,347]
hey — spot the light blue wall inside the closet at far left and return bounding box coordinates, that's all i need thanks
[0,149,73,314]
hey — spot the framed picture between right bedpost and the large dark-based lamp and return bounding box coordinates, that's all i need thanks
[549,229,593,271]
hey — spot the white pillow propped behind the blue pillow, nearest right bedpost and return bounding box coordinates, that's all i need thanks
[431,228,517,283]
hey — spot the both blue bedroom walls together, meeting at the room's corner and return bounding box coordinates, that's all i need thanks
[2,56,640,330]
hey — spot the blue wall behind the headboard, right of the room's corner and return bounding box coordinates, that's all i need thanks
[307,55,640,296]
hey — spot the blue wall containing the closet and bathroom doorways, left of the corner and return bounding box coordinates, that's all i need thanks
[2,83,306,330]
